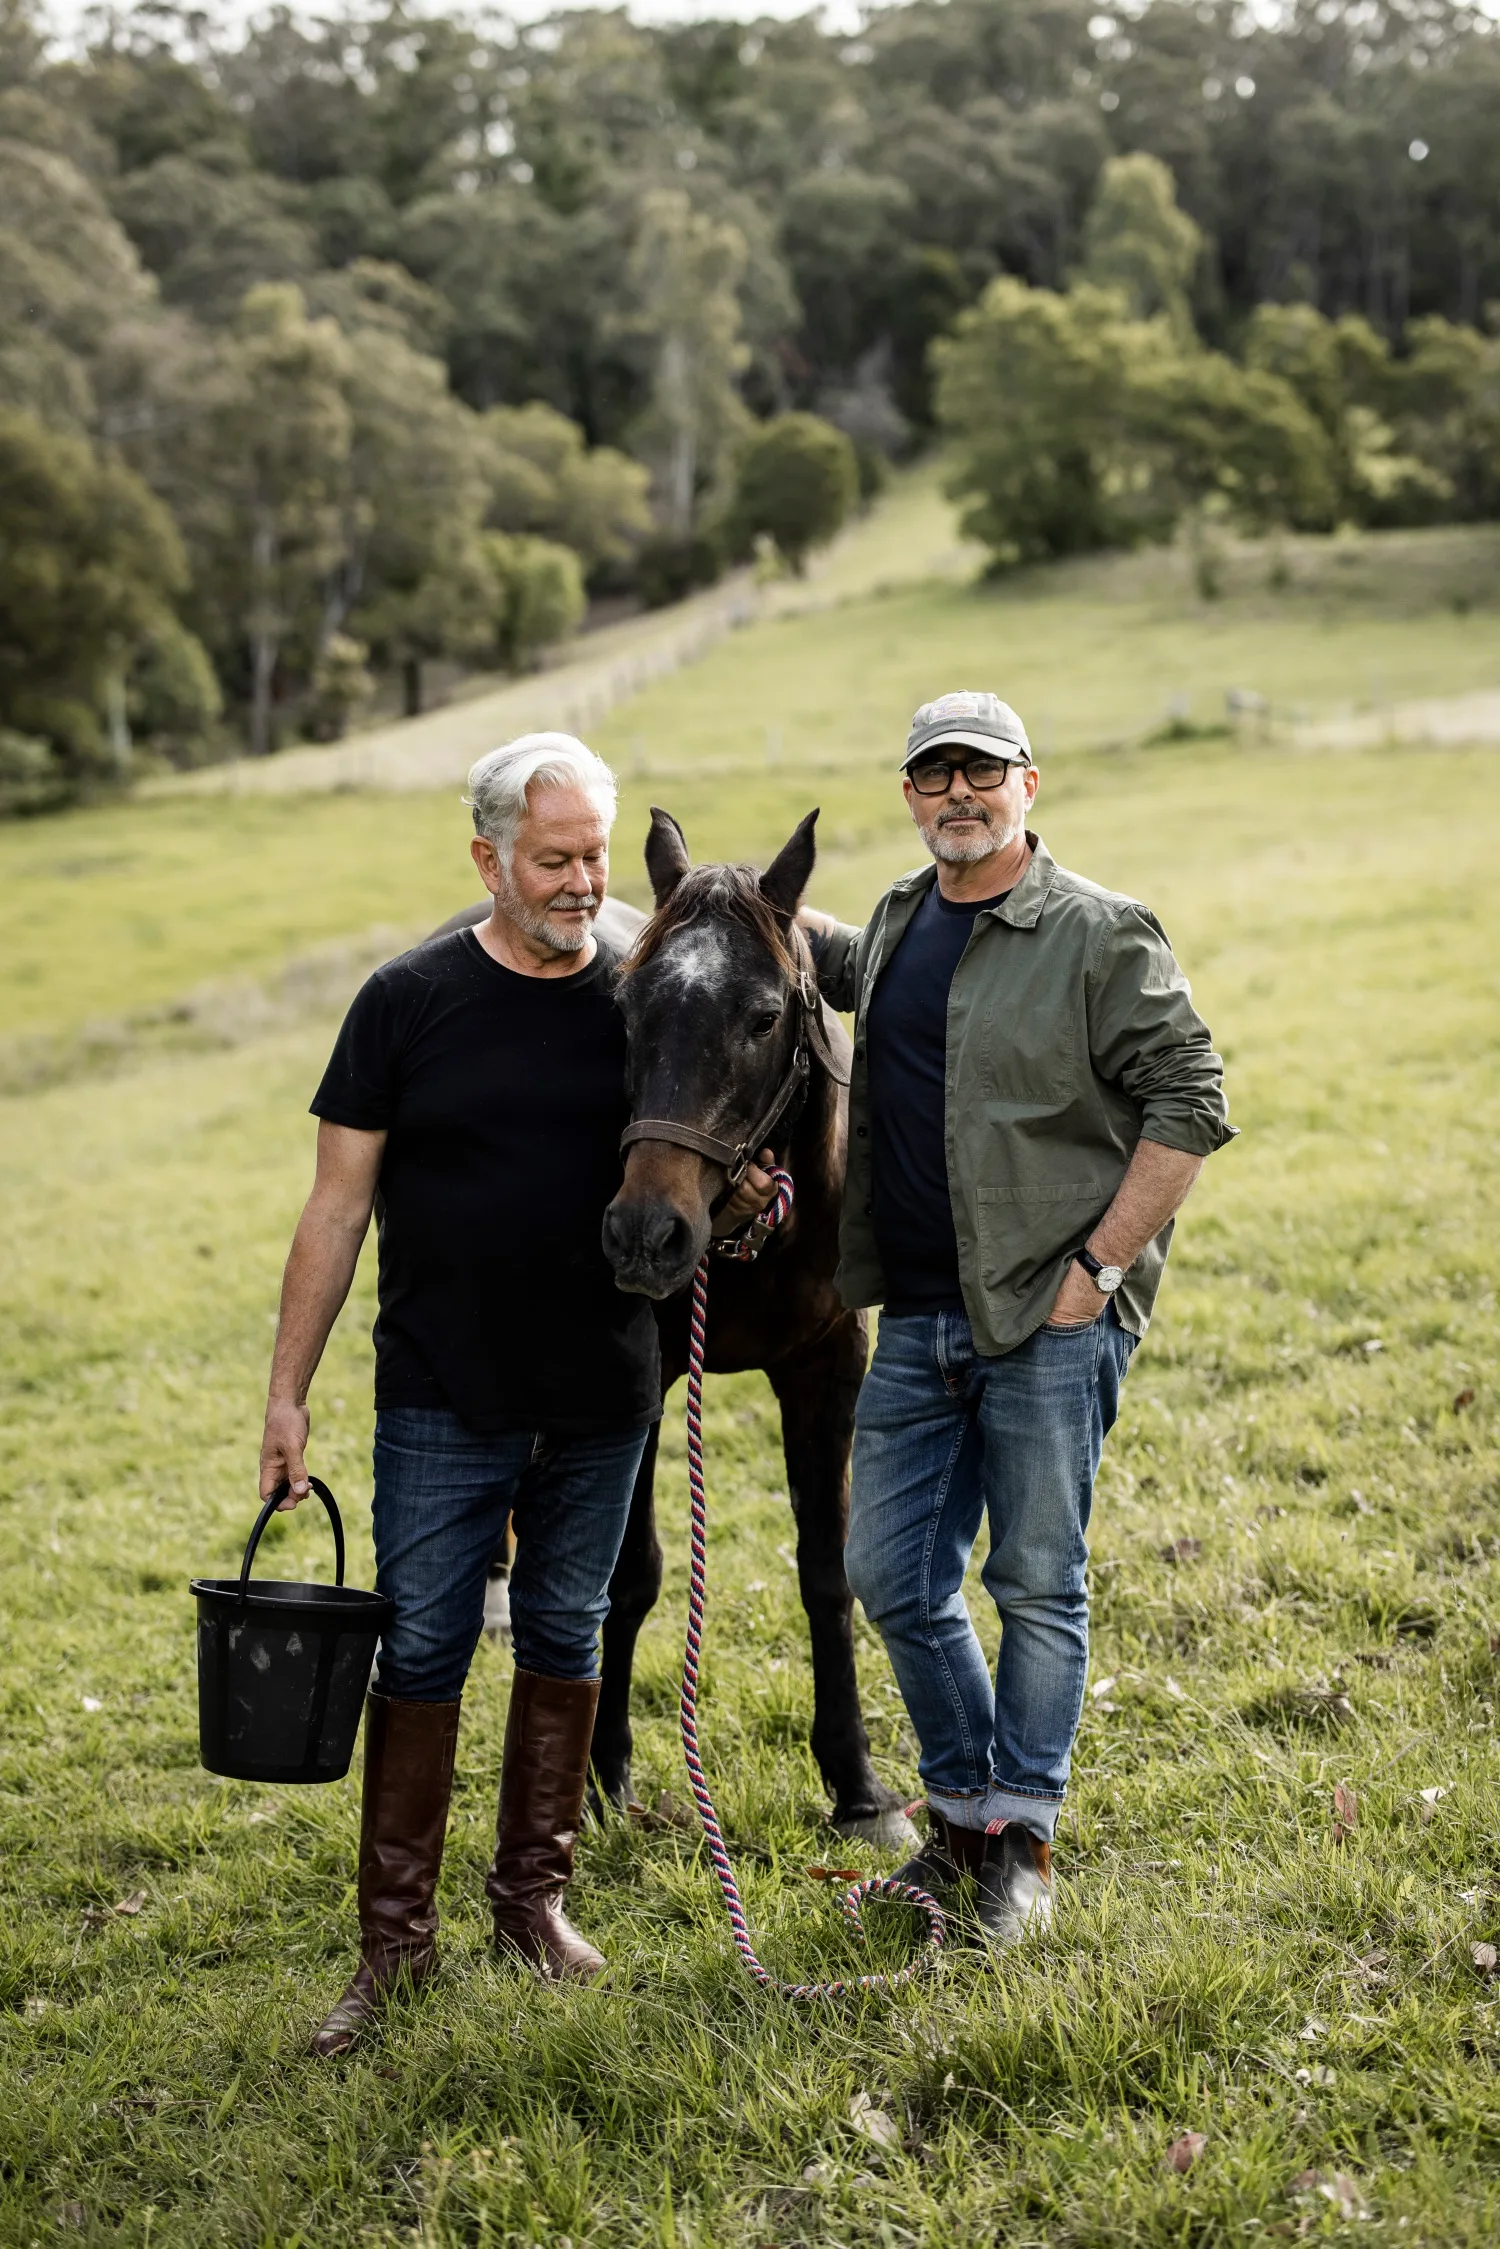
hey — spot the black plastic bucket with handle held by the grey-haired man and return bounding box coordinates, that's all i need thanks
[191,1475,394,1781]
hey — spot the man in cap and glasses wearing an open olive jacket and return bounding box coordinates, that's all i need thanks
[803,693,1232,1945]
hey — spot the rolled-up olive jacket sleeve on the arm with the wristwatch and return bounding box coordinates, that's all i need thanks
[1088,904,1237,1156]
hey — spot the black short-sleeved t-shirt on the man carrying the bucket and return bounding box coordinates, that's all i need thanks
[313,929,661,1435]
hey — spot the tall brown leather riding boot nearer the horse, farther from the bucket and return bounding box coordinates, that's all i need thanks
[484,1664,605,1984]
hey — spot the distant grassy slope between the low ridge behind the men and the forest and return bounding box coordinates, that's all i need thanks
[0,506,1500,1048]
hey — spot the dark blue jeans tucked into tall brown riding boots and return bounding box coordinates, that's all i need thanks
[373,1406,645,1702]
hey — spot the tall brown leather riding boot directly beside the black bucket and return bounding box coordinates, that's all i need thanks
[313,1693,459,2060]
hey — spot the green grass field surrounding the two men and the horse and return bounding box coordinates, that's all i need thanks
[0,517,1500,2249]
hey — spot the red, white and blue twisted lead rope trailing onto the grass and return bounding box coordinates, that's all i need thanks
[681,1169,945,1999]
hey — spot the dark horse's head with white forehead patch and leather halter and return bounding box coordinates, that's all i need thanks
[603,807,816,1298]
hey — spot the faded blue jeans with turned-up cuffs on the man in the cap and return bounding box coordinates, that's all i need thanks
[843,1304,1136,1840]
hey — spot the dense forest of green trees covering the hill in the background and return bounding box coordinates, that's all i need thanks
[0,0,1500,810]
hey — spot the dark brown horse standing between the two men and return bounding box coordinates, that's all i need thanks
[448,810,913,1849]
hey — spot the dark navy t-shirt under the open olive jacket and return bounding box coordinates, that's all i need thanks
[866,884,1010,1318]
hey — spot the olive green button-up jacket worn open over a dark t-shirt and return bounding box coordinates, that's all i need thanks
[814,837,1235,1356]
